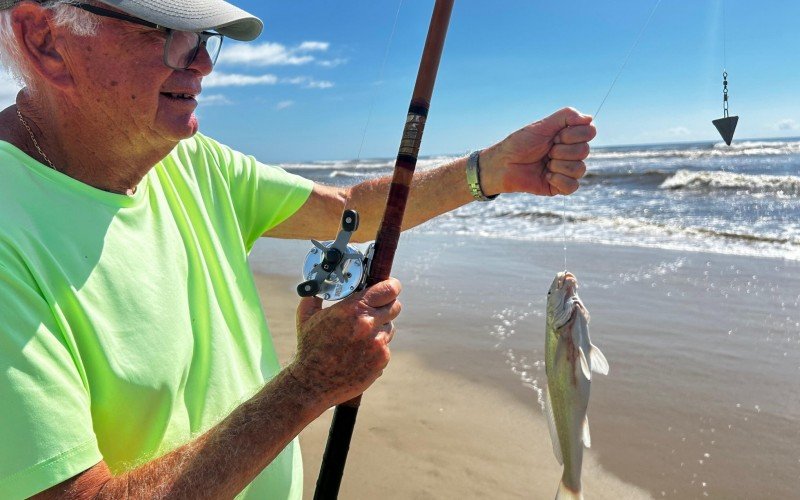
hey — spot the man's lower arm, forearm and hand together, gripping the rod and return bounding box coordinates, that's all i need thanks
[34,279,401,500]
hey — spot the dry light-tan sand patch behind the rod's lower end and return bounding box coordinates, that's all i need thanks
[257,266,649,499]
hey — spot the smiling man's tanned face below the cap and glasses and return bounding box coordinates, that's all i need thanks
[57,11,212,147]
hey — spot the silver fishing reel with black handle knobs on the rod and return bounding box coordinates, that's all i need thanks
[297,210,375,300]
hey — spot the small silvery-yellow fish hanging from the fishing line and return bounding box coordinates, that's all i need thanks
[544,271,608,500]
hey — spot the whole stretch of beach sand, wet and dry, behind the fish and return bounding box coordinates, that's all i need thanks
[251,233,800,499]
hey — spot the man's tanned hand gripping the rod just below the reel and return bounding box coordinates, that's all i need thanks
[288,278,401,406]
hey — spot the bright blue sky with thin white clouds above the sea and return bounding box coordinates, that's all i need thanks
[0,0,800,162]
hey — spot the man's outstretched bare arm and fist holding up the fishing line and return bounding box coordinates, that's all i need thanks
[264,108,596,241]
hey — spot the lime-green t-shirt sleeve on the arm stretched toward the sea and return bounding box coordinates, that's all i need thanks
[197,134,314,250]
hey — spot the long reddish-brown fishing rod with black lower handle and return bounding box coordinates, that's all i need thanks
[314,0,455,500]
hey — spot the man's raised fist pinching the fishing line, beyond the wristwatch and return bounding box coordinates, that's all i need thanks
[480,108,597,196]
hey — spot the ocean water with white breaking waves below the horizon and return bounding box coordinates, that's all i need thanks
[283,138,800,260]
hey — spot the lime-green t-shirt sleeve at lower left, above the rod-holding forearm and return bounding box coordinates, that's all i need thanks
[0,265,102,499]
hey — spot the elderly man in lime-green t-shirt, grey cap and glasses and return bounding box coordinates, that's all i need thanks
[0,0,595,499]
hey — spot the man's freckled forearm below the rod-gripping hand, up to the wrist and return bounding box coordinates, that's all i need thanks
[34,370,325,499]
